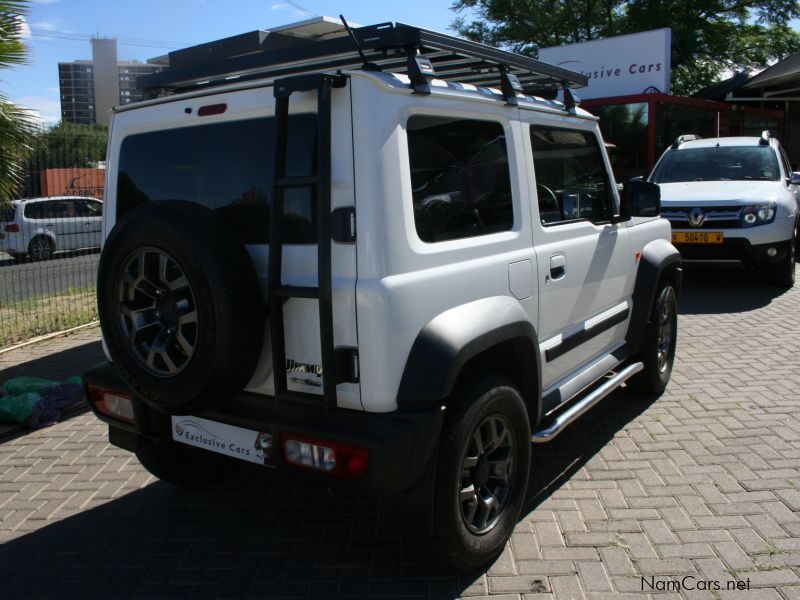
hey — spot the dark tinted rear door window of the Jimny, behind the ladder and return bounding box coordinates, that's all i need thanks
[117,114,317,244]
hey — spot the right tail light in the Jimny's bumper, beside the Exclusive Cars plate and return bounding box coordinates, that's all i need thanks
[281,433,369,480]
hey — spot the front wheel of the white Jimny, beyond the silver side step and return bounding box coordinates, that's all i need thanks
[627,282,678,396]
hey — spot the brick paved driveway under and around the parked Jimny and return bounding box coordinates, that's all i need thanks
[0,271,800,599]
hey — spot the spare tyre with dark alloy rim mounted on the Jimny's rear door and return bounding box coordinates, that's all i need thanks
[97,201,265,414]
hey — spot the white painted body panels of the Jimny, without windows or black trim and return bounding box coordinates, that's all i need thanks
[104,71,669,413]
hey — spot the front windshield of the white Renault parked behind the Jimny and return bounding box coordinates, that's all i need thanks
[650,146,780,183]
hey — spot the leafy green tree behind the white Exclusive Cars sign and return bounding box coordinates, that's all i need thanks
[452,0,800,94]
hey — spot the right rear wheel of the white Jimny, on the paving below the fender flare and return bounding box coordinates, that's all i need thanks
[434,377,531,568]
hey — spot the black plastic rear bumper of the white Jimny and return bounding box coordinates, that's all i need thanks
[84,362,444,496]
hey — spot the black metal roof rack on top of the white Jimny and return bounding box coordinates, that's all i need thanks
[137,23,588,104]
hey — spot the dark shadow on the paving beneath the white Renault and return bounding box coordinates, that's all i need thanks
[678,265,786,315]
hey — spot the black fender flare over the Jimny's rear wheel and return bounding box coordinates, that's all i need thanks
[397,296,542,423]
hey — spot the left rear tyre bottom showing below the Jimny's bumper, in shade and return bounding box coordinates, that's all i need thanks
[136,438,241,488]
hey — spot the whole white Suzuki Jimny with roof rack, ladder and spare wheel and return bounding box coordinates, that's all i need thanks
[86,20,681,566]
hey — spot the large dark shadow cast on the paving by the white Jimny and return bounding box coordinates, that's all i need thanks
[0,386,648,598]
